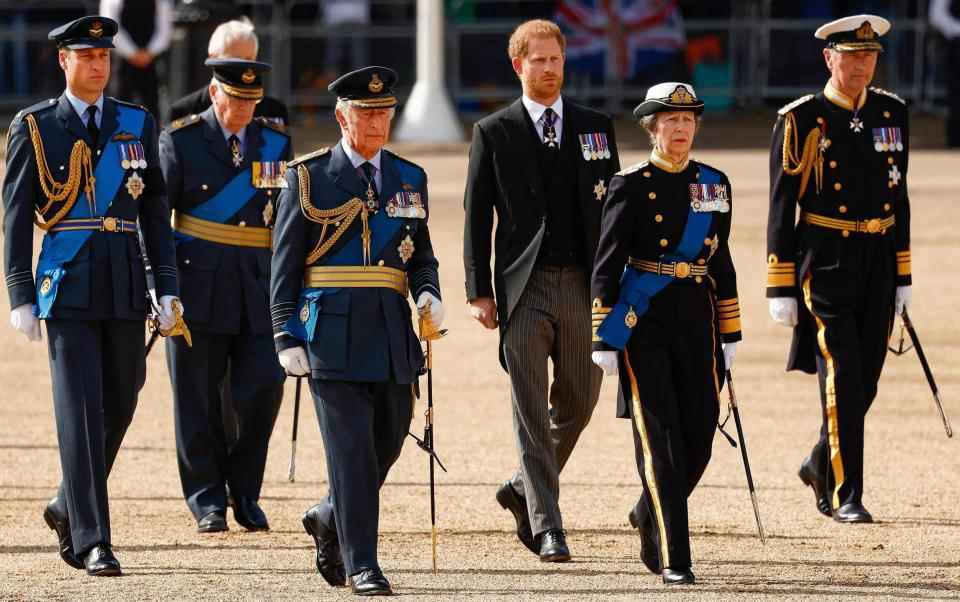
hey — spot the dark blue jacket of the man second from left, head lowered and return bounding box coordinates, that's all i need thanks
[160,107,292,334]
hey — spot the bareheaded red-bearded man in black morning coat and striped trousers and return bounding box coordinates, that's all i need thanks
[463,20,620,562]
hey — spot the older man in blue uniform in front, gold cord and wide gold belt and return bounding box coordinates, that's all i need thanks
[270,67,443,595]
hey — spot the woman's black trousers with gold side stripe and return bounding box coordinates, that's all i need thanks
[620,284,723,569]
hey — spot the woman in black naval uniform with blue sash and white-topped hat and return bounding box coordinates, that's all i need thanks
[592,82,741,585]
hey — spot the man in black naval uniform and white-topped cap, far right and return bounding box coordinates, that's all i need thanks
[767,15,911,523]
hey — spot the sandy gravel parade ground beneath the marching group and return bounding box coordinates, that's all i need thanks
[0,147,960,601]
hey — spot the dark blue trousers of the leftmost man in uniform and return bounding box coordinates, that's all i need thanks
[46,319,146,556]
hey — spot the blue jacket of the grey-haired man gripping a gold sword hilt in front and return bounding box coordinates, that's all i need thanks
[270,144,440,384]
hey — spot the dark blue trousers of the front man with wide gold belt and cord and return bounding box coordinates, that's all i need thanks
[310,378,413,575]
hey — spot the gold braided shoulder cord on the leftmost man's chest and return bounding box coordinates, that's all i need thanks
[27,115,97,230]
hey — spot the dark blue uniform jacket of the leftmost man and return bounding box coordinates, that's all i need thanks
[3,95,177,320]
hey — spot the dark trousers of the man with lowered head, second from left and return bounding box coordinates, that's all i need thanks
[167,332,284,520]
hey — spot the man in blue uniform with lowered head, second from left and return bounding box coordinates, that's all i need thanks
[160,59,291,533]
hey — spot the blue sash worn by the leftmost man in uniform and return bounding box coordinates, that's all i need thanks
[37,105,146,319]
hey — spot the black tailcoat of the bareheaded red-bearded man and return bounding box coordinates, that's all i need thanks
[463,97,620,352]
